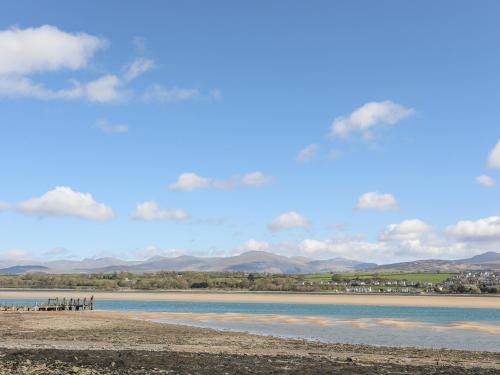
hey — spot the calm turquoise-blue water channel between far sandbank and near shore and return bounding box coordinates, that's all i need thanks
[0,299,500,351]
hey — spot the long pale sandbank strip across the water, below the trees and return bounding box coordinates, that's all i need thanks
[0,290,500,309]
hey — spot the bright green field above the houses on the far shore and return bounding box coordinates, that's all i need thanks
[304,272,454,284]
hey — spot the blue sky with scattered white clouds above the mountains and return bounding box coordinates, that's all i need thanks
[0,0,500,263]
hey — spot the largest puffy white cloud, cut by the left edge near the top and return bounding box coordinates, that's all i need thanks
[0,25,106,76]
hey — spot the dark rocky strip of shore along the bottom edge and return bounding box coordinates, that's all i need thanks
[0,349,499,375]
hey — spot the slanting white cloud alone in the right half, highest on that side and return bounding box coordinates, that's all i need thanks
[331,100,415,138]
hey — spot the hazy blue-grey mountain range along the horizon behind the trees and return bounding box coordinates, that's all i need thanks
[0,251,500,274]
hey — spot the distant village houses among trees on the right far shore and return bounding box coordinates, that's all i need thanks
[301,271,500,294]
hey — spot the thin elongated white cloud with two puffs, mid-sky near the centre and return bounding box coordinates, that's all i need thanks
[168,171,274,192]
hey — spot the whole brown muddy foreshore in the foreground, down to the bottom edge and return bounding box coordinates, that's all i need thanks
[0,311,500,374]
